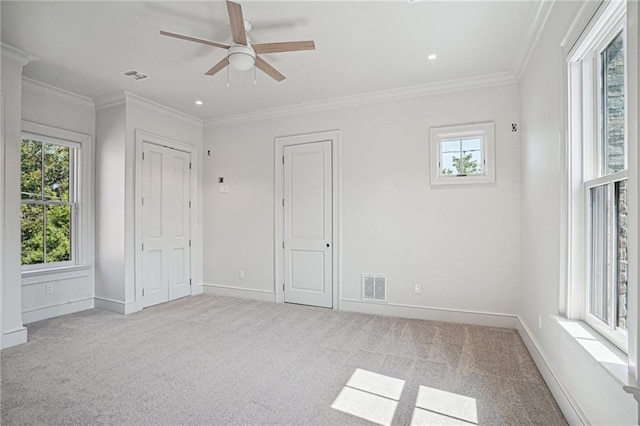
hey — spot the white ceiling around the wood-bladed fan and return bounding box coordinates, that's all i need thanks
[0,0,541,119]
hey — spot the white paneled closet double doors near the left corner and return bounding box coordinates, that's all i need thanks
[142,142,191,307]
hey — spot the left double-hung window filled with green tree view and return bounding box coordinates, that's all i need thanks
[20,133,79,269]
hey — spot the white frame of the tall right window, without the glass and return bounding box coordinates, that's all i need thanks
[560,2,632,353]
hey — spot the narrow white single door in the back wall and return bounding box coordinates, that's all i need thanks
[283,141,333,308]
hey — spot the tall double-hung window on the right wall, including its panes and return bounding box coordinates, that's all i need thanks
[569,3,628,352]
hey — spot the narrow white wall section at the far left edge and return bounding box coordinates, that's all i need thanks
[0,46,28,348]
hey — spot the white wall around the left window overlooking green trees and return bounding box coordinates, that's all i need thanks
[22,79,95,323]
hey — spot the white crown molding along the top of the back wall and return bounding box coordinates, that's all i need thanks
[204,73,518,127]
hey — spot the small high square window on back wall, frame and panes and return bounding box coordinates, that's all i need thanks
[430,122,495,185]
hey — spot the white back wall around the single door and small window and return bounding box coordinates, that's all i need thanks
[204,85,520,322]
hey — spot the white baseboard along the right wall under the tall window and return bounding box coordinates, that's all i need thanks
[516,317,589,426]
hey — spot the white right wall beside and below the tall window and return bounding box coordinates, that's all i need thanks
[519,2,637,424]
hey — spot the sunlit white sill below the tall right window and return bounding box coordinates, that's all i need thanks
[551,315,636,387]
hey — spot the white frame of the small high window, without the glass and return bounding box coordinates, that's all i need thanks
[429,121,495,186]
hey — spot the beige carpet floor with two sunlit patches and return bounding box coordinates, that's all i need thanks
[1,296,566,426]
